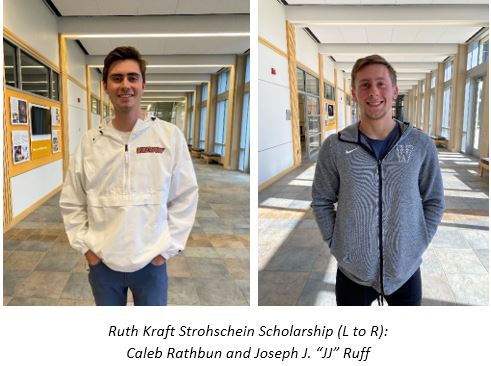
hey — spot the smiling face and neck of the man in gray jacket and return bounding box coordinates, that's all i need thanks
[351,64,398,122]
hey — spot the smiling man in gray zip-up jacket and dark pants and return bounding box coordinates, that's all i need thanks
[312,55,444,305]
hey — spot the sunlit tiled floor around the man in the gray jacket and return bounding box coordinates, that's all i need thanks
[258,151,489,305]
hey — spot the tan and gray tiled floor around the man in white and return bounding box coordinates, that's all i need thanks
[3,159,249,305]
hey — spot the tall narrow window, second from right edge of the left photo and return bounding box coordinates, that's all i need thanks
[213,70,230,156]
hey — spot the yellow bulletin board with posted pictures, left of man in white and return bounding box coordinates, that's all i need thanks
[3,88,63,177]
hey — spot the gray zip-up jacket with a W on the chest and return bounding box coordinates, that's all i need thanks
[312,121,445,295]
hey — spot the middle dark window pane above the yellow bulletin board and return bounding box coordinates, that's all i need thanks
[20,51,49,98]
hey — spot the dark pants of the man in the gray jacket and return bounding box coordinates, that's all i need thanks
[336,268,422,306]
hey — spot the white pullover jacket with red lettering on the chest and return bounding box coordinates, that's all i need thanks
[60,115,198,272]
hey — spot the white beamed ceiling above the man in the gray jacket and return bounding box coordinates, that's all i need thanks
[286,0,489,93]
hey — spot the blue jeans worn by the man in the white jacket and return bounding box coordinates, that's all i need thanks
[89,261,167,306]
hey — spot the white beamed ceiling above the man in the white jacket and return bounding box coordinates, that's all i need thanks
[47,0,250,105]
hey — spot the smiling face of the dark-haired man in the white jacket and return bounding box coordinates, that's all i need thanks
[104,59,145,115]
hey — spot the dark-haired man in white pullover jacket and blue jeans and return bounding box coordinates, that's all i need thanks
[60,47,198,305]
